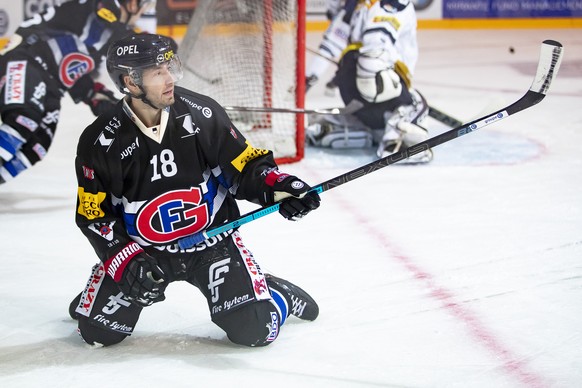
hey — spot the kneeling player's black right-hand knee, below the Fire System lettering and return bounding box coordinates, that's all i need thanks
[213,300,280,346]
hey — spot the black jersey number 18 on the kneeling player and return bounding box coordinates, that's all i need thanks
[75,87,276,262]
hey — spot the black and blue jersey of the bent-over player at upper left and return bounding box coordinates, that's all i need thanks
[14,0,133,90]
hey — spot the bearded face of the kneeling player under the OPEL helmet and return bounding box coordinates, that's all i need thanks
[142,63,176,109]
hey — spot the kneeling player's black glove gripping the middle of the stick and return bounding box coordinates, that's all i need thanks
[264,169,321,221]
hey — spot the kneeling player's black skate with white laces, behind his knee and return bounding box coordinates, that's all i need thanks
[265,274,319,321]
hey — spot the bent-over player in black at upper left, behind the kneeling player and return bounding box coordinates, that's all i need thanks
[0,0,152,183]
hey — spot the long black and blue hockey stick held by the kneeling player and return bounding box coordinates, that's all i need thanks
[178,40,563,249]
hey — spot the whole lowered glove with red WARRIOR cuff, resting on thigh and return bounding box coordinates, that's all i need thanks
[105,243,166,307]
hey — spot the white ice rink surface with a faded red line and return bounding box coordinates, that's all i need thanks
[0,30,582,388]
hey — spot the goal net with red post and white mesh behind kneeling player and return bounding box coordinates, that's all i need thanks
[178,0,305,163]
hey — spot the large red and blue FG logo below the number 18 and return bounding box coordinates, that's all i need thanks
[136,187,210,244]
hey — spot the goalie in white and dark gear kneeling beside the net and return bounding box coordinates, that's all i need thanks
[306,0,432,163]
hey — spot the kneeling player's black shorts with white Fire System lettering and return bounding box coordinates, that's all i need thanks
[75,232,279,343]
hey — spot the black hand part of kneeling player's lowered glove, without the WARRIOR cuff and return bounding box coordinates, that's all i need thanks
[117,252,166,307]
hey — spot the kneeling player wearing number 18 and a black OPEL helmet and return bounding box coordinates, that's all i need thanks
[69,34,320,346]
